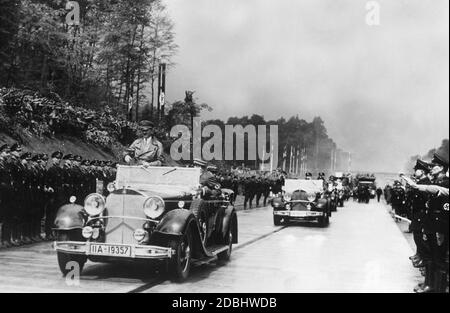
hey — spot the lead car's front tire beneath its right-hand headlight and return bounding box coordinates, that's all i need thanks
[168,228,193,282]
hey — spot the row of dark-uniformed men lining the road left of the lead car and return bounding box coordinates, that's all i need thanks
[0,143,116,247]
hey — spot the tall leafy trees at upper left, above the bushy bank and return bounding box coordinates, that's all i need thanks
[0,0,178,118]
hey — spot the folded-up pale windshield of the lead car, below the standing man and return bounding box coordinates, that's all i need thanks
[116,165,200,188]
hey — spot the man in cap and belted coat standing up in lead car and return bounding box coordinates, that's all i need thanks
[124,120,163,166]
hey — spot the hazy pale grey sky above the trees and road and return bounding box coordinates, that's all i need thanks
[165,0,449,171]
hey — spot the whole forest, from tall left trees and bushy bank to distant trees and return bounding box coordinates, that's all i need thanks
[0,0,350,172]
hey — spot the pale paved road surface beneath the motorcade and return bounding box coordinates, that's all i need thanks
[0,201,422,293]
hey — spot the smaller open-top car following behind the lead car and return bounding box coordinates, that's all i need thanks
[272,179,331,227]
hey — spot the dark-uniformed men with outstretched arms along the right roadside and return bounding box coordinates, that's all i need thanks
[400,154,449,293]
